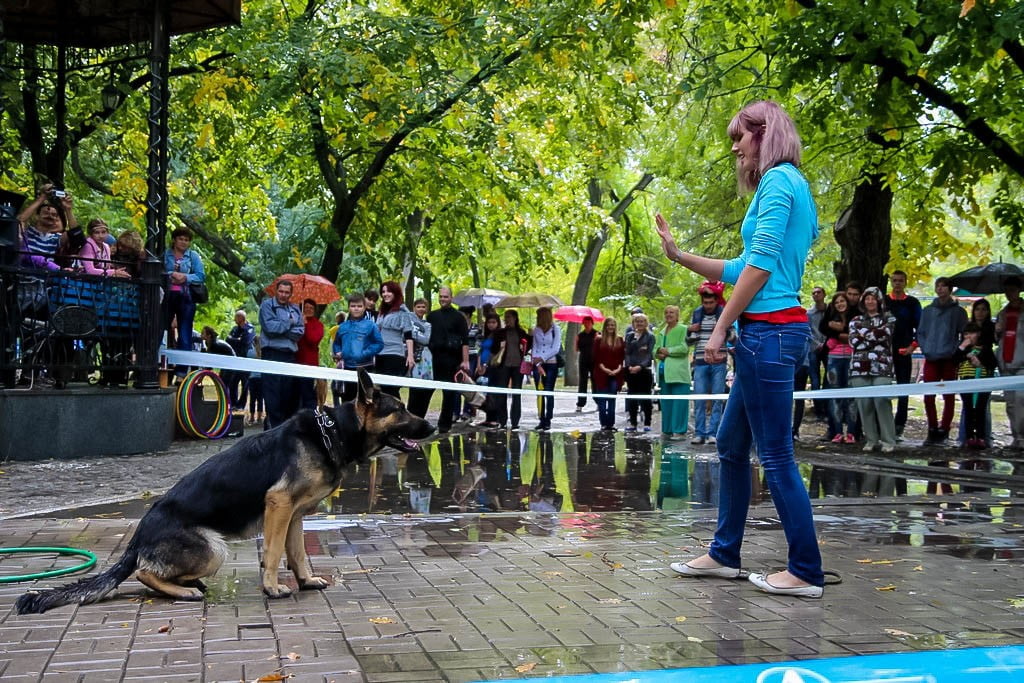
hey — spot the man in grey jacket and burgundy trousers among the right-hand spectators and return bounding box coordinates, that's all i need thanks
[918,278,967,445]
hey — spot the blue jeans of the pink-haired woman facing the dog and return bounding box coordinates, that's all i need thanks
[709,323,824,586]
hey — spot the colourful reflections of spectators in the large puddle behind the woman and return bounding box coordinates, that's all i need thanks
[322,431,1012,514]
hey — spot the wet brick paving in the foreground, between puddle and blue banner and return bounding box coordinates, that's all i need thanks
[0,499,1024,681]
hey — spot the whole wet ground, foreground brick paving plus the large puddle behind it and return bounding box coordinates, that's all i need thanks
[0,397,1024,681]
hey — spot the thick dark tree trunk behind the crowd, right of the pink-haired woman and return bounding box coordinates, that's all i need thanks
[833,174,893,291]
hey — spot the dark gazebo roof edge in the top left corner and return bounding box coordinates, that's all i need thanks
[0,0,242,48]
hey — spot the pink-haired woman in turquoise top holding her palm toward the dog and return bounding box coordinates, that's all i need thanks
[656,101,824,598]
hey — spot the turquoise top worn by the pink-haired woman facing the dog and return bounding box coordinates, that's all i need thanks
[722,163,818,313]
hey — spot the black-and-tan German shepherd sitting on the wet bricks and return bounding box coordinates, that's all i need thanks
[16,370,434,614]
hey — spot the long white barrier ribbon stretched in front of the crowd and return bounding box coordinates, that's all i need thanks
[161,348,1024,400]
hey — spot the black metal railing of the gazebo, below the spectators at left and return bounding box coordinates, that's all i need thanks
[0,250,164,389]
